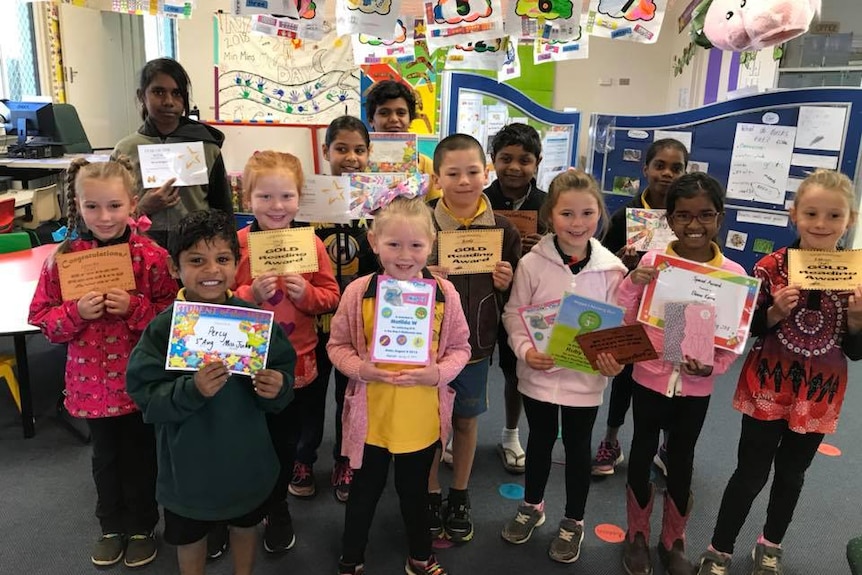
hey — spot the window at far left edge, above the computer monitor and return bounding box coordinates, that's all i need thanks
[0,2,41,100]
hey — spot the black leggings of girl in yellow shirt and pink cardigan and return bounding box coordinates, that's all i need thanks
[341,441,440,565]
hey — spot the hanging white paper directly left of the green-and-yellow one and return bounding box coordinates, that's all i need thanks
[425,0,505,52]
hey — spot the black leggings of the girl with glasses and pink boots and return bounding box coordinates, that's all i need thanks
[628,383,710,513]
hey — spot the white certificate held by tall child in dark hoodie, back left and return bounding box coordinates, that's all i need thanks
[138,142,209,188]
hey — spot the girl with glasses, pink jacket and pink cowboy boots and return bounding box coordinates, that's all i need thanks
[619,173,745,575]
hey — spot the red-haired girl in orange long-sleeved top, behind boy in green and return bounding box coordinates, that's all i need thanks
[236,151,341,553]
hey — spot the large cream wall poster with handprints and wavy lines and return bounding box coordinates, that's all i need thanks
[219,13,360,125]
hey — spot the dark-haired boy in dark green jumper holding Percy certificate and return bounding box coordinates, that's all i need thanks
[126,210,296,575]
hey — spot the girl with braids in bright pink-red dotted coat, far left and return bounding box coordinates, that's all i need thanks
[28,157,177,567]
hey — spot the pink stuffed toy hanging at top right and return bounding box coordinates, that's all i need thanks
[703,0,820,52]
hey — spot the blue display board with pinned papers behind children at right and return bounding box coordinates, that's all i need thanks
[587,88,862,271]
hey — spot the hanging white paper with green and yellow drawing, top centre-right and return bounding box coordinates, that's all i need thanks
[505,0,581,40]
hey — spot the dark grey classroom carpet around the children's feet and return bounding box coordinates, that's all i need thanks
[0,335,862,575]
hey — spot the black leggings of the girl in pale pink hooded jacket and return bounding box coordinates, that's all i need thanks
[520,395,599,521]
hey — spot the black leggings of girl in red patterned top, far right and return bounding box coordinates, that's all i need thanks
[712,415,823,553]
